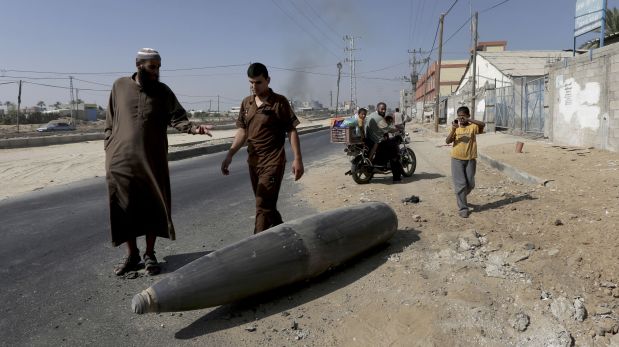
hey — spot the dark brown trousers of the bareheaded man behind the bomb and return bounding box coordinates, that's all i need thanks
[249,165,285,234]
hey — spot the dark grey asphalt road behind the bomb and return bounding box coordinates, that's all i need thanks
[0,131,343,346]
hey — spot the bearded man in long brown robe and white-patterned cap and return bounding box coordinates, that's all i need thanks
[104,48,212,276]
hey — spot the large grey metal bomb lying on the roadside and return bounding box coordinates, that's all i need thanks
[131,202,398,313]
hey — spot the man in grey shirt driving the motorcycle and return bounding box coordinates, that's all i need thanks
[365,101,403,183]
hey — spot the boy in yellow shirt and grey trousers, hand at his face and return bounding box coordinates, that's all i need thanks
[445,106,486,218]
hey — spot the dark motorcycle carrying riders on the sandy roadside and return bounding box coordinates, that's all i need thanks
[344,119,417,184]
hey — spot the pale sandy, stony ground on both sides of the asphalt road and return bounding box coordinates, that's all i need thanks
[0,121,619,346]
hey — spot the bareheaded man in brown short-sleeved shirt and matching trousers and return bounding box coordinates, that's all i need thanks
[221,63,303,233]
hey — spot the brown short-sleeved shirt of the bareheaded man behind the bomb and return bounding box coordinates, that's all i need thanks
[236,88,299,167]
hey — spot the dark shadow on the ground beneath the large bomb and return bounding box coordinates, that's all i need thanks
[174,230,421,340]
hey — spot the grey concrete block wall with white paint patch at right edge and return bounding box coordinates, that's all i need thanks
[545,45,619,152]
